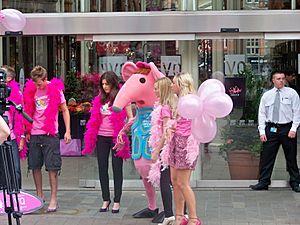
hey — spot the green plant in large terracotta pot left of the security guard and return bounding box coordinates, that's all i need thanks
[220,65,266,180]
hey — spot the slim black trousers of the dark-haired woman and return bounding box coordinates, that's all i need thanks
[96,135,123,202]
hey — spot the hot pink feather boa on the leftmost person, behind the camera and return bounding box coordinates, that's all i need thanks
[7,80,27,159]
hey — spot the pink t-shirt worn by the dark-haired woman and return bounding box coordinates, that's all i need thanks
[98,102,114,137]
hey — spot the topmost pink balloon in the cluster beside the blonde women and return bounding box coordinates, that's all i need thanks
[197,79,225,100]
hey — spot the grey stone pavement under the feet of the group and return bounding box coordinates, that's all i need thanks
[0,188,300,225]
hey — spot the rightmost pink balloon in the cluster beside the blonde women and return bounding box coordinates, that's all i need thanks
[202,93,233,118]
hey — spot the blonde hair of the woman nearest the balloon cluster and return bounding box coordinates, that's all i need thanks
[173,72,195,96]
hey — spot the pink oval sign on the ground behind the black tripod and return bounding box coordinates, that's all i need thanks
[0,191,43,215]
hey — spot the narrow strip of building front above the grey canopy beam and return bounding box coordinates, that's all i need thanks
[2,0,300,13]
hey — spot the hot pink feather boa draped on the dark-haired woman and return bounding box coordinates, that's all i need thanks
[82,96,131,159]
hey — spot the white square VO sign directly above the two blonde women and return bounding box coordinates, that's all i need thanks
[160,55,181,76]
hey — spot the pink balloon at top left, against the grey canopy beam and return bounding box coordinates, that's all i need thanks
[1,9,26,32]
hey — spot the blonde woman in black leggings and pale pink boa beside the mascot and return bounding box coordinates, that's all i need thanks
[149,77,175,225]
